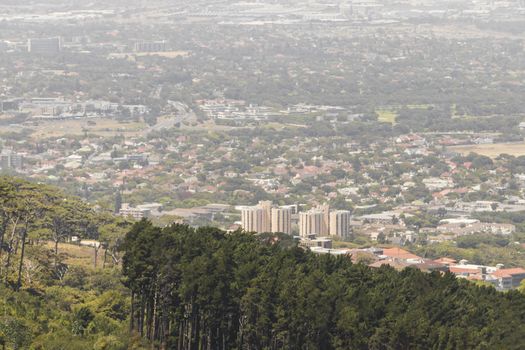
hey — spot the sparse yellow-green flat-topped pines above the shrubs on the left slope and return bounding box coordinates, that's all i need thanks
[0,177,130,289]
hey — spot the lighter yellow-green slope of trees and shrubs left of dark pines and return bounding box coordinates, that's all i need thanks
[0,177,135,350]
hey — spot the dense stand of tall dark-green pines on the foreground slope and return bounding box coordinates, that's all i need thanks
[123,221,525,349]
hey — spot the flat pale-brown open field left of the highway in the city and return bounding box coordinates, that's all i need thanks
[32,118,148,138]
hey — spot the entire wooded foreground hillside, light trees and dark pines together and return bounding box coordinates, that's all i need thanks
[0,178,525,350]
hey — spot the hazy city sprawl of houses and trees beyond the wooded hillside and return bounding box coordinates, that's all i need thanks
[0,1,525,290]
